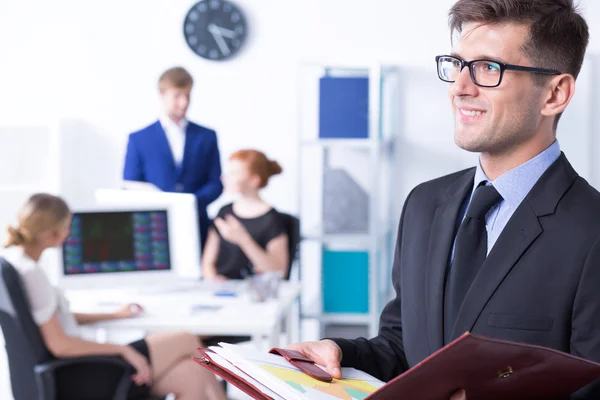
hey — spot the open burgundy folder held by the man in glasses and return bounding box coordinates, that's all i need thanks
[194,332,600,400]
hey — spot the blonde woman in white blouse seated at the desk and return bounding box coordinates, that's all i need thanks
[2,194,225,400]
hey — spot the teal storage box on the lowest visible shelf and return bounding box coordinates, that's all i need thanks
[323,250,369,314]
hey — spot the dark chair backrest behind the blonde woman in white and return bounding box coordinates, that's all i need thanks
[0,258,53,400]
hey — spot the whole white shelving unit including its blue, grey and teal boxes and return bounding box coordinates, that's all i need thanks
[298,64,399,336]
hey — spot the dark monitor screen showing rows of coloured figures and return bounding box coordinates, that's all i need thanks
[62,210,171,275]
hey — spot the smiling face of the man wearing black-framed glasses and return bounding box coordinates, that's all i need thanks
[448,23,541,154]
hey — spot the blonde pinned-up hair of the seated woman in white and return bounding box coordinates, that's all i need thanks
[4,193,71,247]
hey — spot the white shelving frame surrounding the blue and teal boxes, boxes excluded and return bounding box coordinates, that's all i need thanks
[298,63,402,336]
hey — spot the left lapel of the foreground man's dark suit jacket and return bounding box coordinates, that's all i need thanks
[425,169,475,353]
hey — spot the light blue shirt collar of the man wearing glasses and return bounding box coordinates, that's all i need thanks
[471,140,560,208]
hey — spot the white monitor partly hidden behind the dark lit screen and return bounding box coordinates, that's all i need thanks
[95,189,202,280]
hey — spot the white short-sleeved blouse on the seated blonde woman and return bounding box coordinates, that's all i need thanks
[2,246,80,337]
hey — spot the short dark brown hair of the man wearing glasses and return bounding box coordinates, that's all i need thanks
[450,0,589,78]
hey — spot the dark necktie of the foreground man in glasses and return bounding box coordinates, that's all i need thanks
[444,185,502,343]
